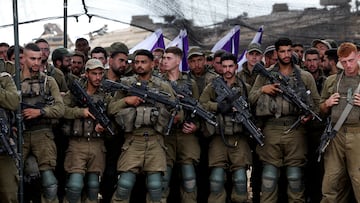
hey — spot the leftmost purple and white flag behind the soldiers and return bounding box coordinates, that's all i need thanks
[129,29,165,54]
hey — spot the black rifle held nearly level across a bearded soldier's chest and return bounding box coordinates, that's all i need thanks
[102,80,180,135]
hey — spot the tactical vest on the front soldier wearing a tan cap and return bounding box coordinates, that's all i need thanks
[70,90,107,137]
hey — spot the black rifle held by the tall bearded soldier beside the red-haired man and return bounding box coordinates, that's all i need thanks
[253,63,322,133]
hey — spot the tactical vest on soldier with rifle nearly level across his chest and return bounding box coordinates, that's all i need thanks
[115,76,171,134]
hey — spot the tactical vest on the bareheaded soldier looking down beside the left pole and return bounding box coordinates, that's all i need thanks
[21,73,56,129]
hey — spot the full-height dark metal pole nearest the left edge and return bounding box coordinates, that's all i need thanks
[13,0,24,203]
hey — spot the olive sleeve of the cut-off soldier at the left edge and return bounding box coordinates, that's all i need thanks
[0,75,20,111]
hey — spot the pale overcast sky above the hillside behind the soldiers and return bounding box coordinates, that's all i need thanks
[0,0,354,44]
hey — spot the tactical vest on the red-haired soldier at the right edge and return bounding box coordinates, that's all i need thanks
[331,73,360,124]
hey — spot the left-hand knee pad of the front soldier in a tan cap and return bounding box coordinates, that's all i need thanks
[66,173,84,202]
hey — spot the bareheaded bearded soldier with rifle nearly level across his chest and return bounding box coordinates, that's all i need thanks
[108,50,176,202]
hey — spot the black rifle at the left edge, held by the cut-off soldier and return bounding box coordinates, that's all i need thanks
[0,118,21,164]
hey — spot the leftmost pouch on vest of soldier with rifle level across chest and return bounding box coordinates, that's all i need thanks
[115,107,136,133]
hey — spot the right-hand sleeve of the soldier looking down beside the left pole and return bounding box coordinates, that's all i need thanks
[44,76,65,118]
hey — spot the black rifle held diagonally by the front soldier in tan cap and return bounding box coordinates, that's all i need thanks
[69,80,115,135]
